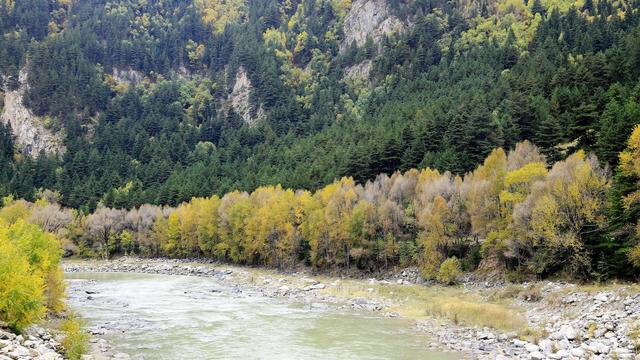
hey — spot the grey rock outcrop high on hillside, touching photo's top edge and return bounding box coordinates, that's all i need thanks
[340,0,404,52]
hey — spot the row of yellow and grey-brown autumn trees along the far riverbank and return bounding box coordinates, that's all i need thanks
[11,127,640,278]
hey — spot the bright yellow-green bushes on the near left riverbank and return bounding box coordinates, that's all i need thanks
[0,197,88,360]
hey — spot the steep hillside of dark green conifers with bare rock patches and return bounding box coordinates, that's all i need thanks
[0,0,640,274]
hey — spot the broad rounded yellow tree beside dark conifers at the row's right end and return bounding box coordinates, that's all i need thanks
[514,151,610,276]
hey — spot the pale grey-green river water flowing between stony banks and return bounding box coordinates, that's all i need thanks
[67,273,456,360]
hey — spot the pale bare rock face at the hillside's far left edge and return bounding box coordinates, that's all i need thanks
[0,71,65,156]
